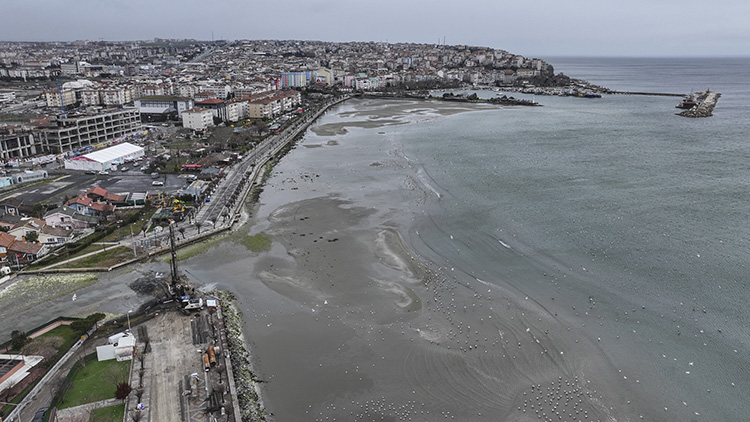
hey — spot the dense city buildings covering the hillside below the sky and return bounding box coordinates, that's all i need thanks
[0,39,580,163]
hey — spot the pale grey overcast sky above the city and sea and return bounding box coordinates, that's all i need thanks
[0,0,750,58]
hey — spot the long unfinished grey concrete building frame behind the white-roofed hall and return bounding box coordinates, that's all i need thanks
[39,108,141,154]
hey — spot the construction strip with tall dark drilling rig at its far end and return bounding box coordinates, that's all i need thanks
[125,223,242,422]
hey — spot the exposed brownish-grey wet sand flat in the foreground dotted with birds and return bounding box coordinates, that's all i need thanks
[222,196,648,421]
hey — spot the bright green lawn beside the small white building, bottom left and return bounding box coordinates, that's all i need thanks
[57,353,132,409]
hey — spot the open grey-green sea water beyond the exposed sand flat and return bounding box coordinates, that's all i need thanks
[400,55,750,421]
